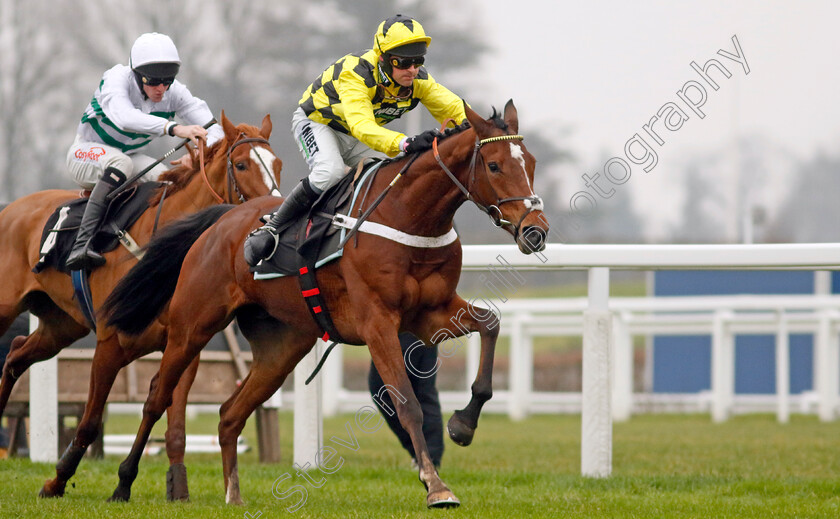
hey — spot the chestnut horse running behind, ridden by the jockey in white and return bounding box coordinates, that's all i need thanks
[0,112,282,499]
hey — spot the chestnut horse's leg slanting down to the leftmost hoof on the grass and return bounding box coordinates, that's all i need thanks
[38,335,127,497]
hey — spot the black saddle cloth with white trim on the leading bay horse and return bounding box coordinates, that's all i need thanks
[251,161,383,279]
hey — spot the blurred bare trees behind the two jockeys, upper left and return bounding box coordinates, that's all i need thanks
[0,0,563,225]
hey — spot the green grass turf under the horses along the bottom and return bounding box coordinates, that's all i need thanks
[0,413,840,519]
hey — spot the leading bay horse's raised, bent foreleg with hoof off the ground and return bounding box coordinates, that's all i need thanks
[424,298,500,446]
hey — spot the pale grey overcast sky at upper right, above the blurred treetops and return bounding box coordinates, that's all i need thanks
[456,0,840,240]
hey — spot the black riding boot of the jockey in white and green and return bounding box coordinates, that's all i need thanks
[65,168,125,270]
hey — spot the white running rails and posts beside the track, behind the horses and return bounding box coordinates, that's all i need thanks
[32,243,840,477]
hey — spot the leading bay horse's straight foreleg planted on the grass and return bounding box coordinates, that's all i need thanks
[363,320,461,508]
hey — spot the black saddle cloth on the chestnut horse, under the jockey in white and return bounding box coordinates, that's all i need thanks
[32,182,161,274]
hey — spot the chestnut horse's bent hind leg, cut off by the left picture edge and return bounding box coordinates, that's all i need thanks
[0,303,88,417]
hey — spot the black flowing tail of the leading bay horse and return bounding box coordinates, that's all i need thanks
[100,205,233,335]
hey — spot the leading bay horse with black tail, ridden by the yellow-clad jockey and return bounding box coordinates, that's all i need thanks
[100,101,548,507]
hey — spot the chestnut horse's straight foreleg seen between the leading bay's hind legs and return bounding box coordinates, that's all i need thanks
[166,357,199,501]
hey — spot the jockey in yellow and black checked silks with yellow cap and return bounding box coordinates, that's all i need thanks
[245,14,466,266]
